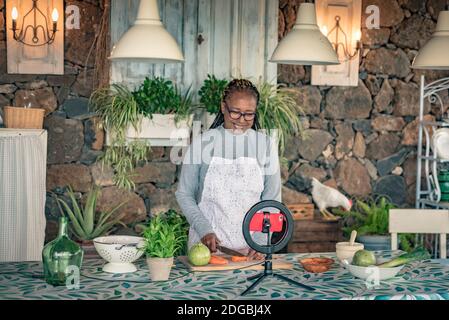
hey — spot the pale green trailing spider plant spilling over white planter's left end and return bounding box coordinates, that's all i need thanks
[89,84,151,190]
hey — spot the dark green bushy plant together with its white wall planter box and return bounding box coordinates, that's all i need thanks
[126,77,193,146]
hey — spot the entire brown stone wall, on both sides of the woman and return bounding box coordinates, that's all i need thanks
[0,0,447,242]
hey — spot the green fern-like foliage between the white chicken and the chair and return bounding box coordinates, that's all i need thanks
[333,197,414,252]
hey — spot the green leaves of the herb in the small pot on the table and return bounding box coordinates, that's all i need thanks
[142,211,187,258]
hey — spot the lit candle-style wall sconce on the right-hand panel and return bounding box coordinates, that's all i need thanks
[321,15,363,63]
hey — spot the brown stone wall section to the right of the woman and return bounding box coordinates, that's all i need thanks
[279,0,449,209]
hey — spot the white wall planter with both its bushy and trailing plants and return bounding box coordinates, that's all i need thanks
[90,78,193,190]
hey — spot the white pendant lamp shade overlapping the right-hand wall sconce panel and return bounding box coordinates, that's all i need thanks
[270,3,340,65]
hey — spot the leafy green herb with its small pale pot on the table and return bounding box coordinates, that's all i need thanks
[143,213,187,281]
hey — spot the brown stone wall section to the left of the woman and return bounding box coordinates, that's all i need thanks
[0,0,179,239]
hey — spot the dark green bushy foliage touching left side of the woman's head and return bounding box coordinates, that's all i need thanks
[198,74,228,114]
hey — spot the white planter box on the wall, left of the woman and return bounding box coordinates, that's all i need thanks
[106,114,193,147]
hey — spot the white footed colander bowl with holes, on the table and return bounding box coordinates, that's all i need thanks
[94,236,144,273]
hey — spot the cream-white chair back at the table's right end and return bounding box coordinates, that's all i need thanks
[389,209,449,259]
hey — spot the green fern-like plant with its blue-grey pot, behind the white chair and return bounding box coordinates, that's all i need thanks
[335,197,413,251]
